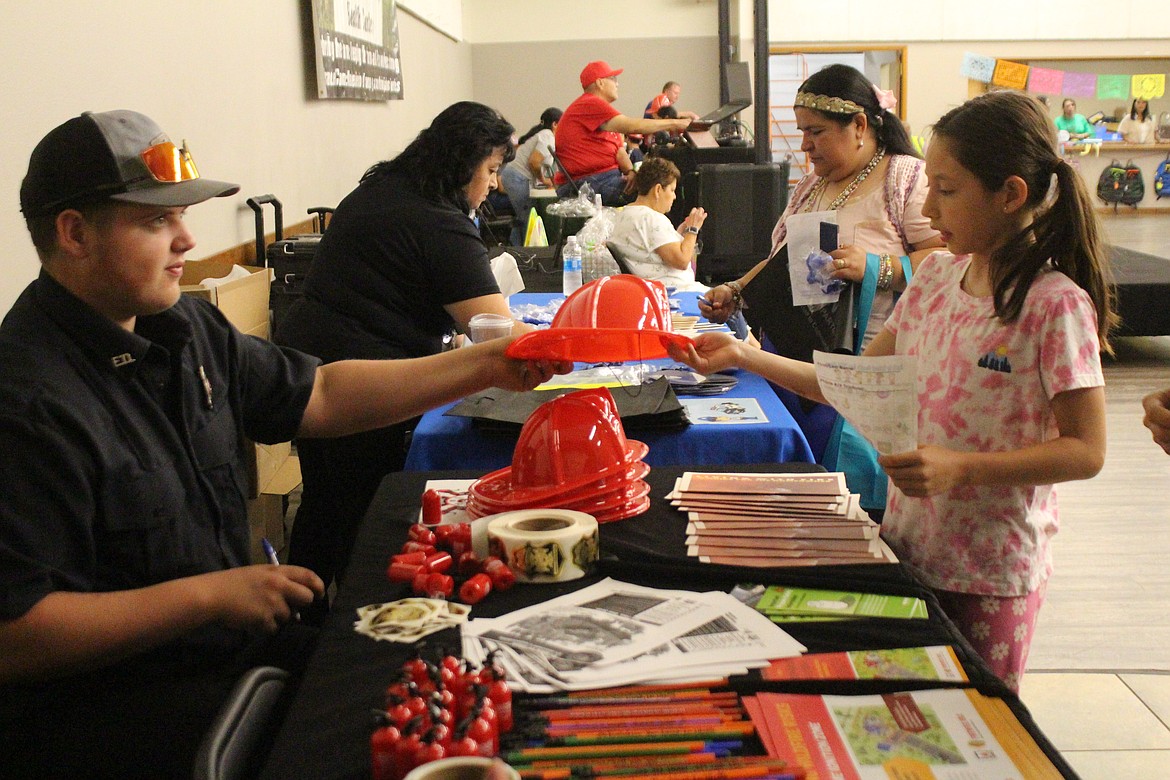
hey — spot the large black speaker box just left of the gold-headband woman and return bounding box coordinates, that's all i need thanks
[697,161,789,283]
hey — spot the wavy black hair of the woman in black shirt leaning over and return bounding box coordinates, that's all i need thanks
[362,101,516,210]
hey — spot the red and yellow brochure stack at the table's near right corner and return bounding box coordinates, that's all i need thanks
[743,688,1062,780]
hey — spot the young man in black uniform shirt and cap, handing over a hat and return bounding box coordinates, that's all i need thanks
[0,111,567,778]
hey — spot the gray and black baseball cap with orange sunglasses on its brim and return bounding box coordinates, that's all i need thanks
[20,111,240,216]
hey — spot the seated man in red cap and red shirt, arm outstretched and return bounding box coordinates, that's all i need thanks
[556,60,690,206]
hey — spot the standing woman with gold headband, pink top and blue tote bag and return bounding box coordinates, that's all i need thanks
[701,64,943,513]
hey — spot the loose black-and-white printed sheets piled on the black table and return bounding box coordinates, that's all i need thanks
[462,579,805,693]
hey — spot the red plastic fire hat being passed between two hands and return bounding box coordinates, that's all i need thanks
[505,274,690,363]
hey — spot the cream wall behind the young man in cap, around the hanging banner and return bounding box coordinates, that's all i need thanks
[0,0,472,312]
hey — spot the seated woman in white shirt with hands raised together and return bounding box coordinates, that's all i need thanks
[610,157,707,292]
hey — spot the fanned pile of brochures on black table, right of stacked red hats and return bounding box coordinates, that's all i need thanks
[667,471,897,566]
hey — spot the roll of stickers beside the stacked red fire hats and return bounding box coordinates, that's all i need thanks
[488,509,598,582]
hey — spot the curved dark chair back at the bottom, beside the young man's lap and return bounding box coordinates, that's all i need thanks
[194,667,289,780]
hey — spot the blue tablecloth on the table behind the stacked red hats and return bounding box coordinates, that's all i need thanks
[406,292,813,471]
